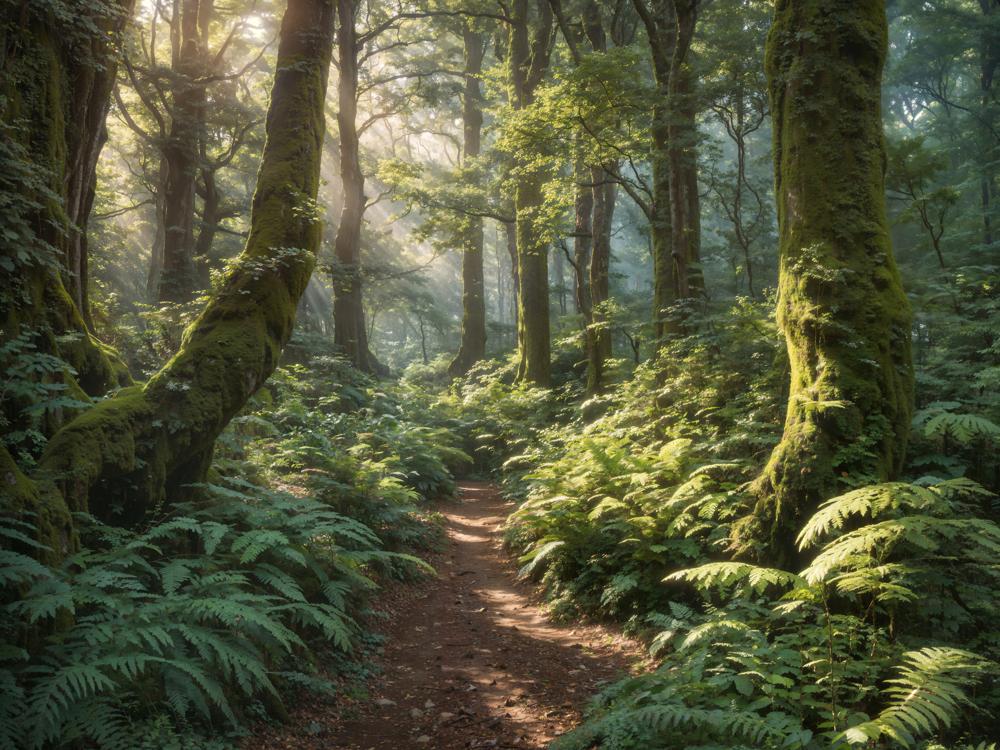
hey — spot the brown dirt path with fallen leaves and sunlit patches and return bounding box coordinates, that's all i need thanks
[244,482,644,750]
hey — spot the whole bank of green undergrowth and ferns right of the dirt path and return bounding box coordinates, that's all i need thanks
[442,290,1000,750]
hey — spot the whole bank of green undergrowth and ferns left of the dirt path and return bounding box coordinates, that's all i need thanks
[0,338,460,750]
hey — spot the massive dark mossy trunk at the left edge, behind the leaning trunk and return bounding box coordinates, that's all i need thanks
[0,0,132,428]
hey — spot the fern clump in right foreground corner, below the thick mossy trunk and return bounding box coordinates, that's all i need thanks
[557,482,1000,750]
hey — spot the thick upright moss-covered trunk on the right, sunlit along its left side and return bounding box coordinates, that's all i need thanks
[746,0,913,565]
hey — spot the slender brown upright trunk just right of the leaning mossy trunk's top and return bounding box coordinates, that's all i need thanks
[332,0,372,372]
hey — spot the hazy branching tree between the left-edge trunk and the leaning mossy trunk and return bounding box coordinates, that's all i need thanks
[116,0,263,302]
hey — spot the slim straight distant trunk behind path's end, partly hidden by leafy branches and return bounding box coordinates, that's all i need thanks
[448,24,486,377]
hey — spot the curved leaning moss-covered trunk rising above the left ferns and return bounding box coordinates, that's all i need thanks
[35,0,334,523]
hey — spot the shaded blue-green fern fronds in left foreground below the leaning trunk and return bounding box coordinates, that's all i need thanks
[0,482,422,748]
